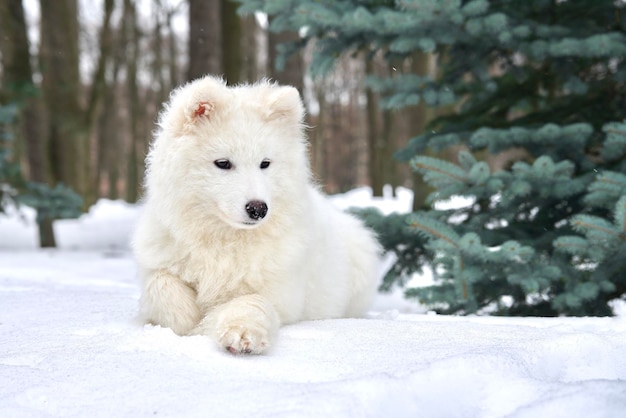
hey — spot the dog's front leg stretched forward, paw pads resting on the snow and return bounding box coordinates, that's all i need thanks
[191,294,280,354]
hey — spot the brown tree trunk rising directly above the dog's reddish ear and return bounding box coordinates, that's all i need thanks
[187,0,222,80]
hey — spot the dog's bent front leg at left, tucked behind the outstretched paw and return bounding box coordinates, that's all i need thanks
[140,270,201,335]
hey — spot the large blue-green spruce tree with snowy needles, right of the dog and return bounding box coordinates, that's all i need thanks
[236,0,626,315]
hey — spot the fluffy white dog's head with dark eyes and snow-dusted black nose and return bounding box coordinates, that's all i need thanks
[147,77,309,229]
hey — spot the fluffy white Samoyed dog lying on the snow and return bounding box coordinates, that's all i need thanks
[133,76,380,354]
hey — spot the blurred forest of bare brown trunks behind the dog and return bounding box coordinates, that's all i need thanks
[0,0,423,207]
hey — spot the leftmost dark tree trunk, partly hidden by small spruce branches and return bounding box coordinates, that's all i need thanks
[0,0,56,247]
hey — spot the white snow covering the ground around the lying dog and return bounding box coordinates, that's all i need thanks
[0,189,626,418]
